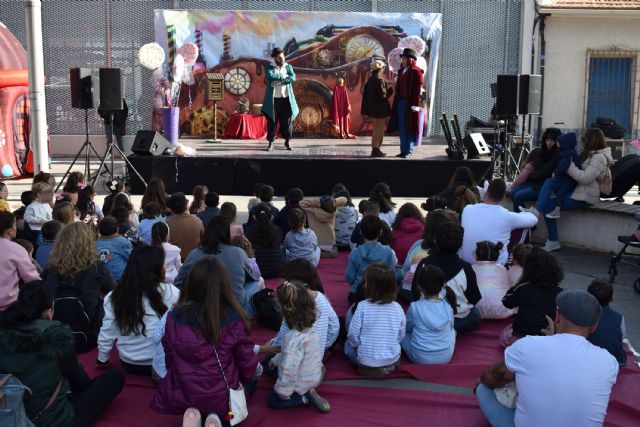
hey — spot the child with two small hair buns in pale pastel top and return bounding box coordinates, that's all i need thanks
[472,240,515,319]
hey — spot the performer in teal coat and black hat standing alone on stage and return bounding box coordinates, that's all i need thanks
[262,47,298,151]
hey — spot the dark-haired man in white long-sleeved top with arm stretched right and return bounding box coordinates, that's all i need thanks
[460,179,538,265]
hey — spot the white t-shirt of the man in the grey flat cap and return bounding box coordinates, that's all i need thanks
[504,334,618,427]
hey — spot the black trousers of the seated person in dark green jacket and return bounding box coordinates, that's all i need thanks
[71,370,124,427]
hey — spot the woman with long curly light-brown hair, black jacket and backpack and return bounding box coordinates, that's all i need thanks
[42,222,115,353]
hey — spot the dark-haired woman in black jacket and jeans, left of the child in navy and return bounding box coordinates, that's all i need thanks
[511,128,562,212]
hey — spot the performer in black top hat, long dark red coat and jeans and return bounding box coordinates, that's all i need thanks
[387,48,423,158]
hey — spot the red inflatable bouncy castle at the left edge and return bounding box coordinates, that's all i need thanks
[0,22,33,179]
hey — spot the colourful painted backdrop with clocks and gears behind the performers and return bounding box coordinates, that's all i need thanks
[154,10,442,137]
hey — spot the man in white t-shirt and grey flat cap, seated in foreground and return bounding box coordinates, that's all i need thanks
[476,289,618,427]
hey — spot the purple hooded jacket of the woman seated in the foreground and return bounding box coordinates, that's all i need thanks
[149,310,258,419]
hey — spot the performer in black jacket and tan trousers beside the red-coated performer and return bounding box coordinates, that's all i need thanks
[360,59,393,157]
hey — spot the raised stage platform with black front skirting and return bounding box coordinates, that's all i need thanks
[129,137,491,197]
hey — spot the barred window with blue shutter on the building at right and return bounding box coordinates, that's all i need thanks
[584,50,640,138]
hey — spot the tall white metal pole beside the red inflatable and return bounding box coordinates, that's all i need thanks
[24,0,49,173]
